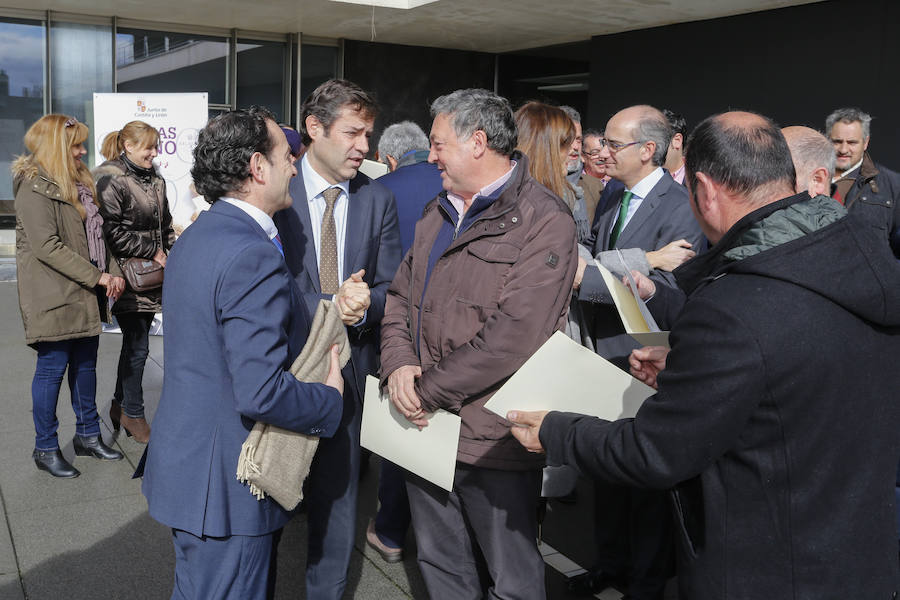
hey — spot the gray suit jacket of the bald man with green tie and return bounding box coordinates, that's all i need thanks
[578,172,706,370]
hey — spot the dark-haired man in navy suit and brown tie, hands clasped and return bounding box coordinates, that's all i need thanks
[275,79,400,600]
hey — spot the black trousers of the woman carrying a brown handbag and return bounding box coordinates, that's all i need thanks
[113,312,153,419]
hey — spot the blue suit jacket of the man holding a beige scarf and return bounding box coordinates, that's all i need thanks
[143,201,343,537]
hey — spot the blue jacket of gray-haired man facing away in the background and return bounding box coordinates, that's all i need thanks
[378,162,444,255]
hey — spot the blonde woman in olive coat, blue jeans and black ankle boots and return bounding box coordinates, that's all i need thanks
[12,115,125,477]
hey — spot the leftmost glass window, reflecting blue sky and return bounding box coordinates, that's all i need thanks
[0,19,46,202]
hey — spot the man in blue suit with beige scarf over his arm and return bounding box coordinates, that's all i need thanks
[143,109,343,600]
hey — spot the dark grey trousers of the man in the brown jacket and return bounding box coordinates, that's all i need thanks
[407,464,546,600]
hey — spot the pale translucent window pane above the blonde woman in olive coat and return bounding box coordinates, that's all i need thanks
[50,22,112,166]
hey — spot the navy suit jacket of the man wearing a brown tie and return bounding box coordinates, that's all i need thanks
[274,168,401,400]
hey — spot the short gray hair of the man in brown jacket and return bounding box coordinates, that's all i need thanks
[431,88,519,156]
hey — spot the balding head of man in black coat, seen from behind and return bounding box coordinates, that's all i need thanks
[686,112,795,243]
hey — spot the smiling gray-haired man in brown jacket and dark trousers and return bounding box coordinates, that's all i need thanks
[381,90,577,600]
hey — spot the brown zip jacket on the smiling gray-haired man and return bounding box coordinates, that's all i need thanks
[381,154,577,470]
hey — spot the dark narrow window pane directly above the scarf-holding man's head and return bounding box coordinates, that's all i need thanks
[237,40,286,122]
